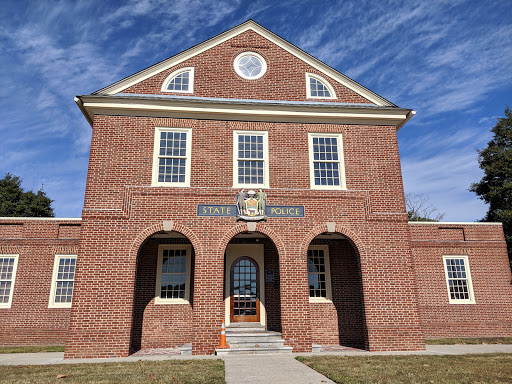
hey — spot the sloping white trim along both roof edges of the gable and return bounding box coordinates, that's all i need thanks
[93,20,395,106]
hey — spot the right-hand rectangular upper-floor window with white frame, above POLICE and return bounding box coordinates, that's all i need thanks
[308,133,346,189]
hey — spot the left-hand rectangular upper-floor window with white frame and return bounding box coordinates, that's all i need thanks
[152,127,192,187]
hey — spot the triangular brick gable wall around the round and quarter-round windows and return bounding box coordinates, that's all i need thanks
[122,31,371,103]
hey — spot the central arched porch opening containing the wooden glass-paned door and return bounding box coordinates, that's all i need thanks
[224,232,281,332]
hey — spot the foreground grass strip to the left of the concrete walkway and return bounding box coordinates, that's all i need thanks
[0,360,225,384]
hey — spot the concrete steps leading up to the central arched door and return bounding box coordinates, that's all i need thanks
[215,323,292,356]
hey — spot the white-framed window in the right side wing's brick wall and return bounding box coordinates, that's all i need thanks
[443,256,475,304]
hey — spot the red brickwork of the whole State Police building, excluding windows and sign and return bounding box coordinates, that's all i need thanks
[0,21,512,358]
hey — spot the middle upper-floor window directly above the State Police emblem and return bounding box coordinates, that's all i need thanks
[233,131,269,188]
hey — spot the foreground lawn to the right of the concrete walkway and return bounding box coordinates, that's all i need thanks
[297,353,512,384]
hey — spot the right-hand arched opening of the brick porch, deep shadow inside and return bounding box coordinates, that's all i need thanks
[307,233,368,349]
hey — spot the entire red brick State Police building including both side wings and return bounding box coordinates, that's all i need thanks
[0,21,512,358]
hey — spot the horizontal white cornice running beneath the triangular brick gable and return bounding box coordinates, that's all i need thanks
[77,95,410,126]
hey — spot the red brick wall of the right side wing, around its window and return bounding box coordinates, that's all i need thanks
[410,223,512,338]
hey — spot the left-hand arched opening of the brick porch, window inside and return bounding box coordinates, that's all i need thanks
[130,231,195,353]
